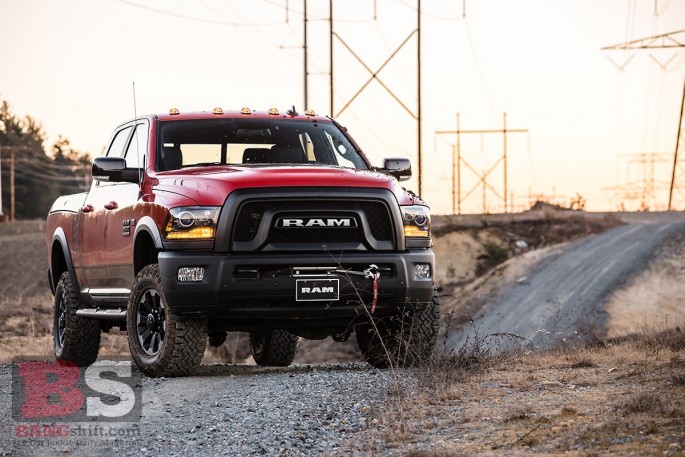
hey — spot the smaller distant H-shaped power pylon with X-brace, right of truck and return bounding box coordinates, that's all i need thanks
[435,113,528,214]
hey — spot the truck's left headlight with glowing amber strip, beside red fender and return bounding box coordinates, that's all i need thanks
[164,206,221,240]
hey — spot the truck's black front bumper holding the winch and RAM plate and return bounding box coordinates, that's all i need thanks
[159,249,434,330]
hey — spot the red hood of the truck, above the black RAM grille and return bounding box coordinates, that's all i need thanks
[154,165,425,206]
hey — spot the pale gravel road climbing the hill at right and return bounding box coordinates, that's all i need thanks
[447,213,685,350]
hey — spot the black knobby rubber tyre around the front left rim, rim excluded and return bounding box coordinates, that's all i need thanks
[126,264,207,377]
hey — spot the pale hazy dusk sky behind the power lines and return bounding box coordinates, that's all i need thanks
[0,0,685,213]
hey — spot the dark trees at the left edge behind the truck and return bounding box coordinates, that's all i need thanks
[0,101,91,219]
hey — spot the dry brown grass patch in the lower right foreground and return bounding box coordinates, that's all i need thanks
[357,330,685,456]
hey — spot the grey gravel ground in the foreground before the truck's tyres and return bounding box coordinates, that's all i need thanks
[0,363,392,456]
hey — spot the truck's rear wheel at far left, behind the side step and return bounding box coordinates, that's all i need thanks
[52,271,100,367]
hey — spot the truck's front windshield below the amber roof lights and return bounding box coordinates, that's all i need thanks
[157,119,368,171]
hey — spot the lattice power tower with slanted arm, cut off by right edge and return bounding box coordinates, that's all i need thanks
[602,30,685,211]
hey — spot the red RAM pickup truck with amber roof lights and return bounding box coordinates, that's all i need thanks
[46,108,439,376]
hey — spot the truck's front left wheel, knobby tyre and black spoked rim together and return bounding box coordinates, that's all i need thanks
[126,264,207,377]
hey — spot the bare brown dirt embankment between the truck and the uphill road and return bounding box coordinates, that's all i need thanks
[434,208,624,329]
